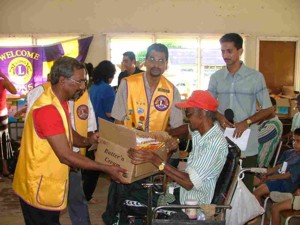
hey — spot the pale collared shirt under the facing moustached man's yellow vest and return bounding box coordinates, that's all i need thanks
[111,73,183,128]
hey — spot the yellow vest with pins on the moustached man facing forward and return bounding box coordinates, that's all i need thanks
[124,72,174,132]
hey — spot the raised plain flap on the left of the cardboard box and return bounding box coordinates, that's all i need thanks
[99,118,136,149]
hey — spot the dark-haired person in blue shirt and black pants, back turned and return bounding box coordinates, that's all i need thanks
[83,60,116,204]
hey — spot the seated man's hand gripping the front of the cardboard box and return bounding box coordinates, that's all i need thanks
[127,148,155,165]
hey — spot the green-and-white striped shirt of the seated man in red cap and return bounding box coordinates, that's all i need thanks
[180,123,228,204]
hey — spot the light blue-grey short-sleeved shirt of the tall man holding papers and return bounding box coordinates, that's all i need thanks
[208,62,272,156]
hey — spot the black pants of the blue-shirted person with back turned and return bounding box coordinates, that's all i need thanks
[82,151,100,201]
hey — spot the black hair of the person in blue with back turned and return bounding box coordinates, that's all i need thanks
[93,60,116,84]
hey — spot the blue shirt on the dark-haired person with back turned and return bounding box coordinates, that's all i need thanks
[89,81,115,129]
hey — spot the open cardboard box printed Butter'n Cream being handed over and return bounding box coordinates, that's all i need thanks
[95,118,167,183]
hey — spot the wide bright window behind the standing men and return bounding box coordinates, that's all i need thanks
[107,34,244,97]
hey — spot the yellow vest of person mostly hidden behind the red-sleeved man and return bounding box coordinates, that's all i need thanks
[73,90,89,156]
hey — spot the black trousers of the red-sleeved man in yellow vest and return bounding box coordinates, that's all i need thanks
[20,198,60,225]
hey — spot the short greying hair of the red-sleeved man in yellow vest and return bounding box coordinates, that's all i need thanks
[49,56,85,85]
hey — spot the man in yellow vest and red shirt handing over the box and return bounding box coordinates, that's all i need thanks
[13,56,126,225]
